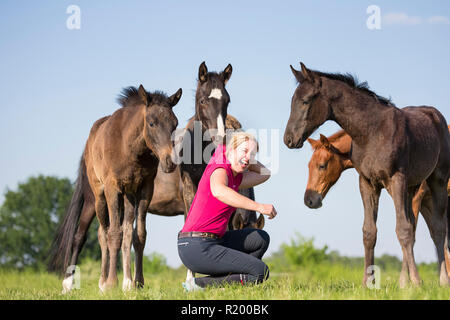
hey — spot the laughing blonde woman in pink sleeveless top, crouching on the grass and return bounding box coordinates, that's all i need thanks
[178,132,277,291]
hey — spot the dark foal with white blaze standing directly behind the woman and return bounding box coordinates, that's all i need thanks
[179,61,264,280]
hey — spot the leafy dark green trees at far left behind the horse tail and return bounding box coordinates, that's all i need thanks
[0,175,100,269]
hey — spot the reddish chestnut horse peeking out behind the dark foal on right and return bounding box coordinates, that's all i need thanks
[304,126,450,277]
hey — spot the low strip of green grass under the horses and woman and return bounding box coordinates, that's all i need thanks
[0,259,450,300]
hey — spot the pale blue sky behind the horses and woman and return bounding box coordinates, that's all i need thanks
[0,0,450,266]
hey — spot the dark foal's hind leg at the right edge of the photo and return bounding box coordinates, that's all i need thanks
[427,170,450,286]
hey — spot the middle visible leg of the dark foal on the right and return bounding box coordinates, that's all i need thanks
[388,173,421,288]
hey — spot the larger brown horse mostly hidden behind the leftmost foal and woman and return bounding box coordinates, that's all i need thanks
[49,96,264,293]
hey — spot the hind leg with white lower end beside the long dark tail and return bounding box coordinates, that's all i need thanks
[63,200,95,293]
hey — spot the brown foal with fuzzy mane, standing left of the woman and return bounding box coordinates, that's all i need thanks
[73,85,182,291]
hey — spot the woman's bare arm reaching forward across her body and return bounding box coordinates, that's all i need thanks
[210,168,277,219]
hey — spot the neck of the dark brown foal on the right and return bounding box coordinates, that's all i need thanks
[329,80,393,144]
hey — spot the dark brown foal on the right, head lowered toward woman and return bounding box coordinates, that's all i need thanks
[284,63,450,288]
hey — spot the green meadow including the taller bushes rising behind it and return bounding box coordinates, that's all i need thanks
[0,237,450,300]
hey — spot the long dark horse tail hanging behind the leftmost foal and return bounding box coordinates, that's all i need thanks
[48,153,89,273]
